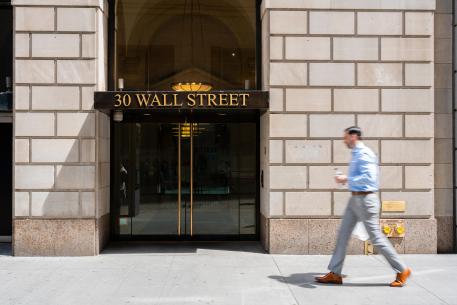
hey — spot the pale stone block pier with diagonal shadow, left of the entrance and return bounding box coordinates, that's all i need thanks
[12,0,109,255]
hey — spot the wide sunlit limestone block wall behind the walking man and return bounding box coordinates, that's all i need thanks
[261,0,437,254]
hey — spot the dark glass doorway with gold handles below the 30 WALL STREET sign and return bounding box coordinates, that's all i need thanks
[113,114,258,240]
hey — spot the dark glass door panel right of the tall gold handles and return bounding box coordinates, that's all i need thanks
[192,123,239,235]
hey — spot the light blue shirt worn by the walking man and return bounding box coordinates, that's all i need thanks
[348,141,379,192]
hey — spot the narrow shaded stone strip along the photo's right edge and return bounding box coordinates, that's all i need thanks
[435,0,455,253]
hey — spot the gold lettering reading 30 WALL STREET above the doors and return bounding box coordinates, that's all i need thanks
[113,92,250,108]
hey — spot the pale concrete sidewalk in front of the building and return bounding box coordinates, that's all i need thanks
[0,242,457,305]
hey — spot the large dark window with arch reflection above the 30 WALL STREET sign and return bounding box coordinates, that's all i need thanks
[114,0,256,90]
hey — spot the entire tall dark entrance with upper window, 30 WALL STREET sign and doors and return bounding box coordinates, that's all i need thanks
[107,0,267,240]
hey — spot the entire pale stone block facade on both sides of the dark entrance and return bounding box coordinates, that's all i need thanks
[8,0,455,256]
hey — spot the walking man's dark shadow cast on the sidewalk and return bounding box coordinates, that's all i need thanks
[269,272,389,288]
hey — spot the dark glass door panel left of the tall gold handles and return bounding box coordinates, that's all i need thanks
[131,123,180,235]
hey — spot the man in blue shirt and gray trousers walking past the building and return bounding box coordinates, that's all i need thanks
[316,126,411,287]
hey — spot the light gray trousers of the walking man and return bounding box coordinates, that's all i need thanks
[328,194,406,274]
